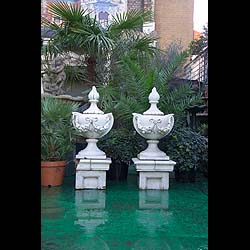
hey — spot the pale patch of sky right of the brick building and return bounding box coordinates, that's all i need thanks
[194,0,208,32]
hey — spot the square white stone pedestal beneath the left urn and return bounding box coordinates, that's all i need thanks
[75,158,111,189]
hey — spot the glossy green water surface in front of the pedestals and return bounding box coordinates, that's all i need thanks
[41,168,208,250]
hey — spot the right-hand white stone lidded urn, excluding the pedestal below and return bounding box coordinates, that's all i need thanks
[133,87,174,160]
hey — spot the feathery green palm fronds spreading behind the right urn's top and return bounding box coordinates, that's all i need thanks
[98,42,202,129]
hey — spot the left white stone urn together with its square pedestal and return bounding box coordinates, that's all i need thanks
[72,86,114,189]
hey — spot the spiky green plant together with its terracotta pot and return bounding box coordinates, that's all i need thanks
[41,96,78,186]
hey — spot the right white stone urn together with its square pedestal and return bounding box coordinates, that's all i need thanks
[132,88,176,190]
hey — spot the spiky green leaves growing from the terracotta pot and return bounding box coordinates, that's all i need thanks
[41,97,78,161]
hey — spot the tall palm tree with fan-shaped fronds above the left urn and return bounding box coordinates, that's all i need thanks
[42,2,156,85]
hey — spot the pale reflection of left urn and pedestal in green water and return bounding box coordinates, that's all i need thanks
[75,190,108,237]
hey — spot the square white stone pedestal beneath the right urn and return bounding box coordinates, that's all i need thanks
[132,158,176,190]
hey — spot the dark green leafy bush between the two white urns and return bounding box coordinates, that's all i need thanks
[98,128,145,165]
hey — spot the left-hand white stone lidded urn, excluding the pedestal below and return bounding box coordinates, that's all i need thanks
[72,86,114,159]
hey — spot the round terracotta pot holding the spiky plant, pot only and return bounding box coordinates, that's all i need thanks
[41,161,66,187]
